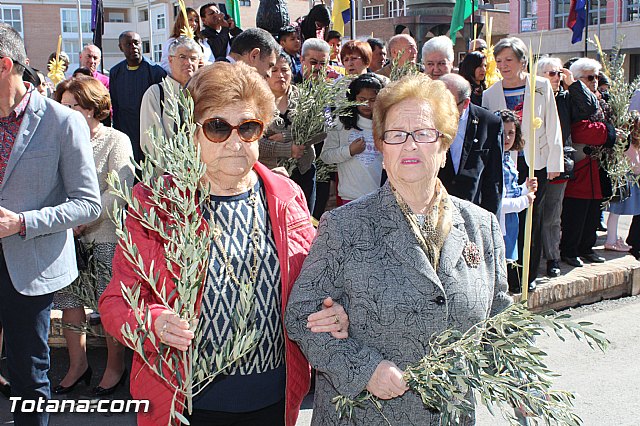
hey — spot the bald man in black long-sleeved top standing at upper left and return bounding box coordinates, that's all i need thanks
[109,31,167,162]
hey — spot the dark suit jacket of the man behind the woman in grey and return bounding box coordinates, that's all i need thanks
[438,104,504,215]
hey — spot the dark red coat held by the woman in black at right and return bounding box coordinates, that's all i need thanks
[564,120,616,200]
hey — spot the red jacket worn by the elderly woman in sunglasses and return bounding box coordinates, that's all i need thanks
[99,163,315,426]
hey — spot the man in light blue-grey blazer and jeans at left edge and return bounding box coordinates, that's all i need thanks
[0,23,100,426]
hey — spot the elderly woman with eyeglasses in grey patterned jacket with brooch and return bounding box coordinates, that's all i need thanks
[285,75,511,425]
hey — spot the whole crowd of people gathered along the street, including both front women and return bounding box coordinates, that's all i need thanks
[0,3,640,426]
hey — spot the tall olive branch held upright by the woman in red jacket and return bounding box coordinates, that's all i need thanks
[108,80,259,425]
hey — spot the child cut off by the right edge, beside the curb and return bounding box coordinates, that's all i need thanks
[604,111,640,252]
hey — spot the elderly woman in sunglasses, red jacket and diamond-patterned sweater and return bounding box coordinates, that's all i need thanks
[100,62,348,426]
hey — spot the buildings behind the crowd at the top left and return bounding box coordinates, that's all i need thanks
[0,0,309,74]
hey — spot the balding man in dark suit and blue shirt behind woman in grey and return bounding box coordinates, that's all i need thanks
[438,74,504,215]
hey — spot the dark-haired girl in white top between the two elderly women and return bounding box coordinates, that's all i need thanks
[320,73,383,205]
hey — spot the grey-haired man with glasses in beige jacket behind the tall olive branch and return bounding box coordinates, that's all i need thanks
[140,37,202,154]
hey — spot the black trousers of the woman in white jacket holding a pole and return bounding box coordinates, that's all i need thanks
[518,157,547,283]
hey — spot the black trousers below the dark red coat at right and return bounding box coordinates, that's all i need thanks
[560,197,601,257]
